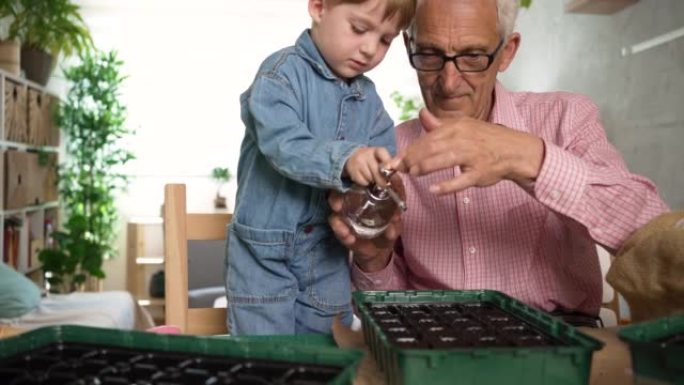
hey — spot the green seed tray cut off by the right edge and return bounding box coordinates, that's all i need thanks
[618,314,684,385]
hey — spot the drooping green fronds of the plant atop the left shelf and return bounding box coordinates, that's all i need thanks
[6,0,93,57]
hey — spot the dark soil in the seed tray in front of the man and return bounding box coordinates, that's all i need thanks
[368,302,562,349]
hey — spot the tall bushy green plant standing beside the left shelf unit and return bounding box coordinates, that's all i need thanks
[39,50,133,292]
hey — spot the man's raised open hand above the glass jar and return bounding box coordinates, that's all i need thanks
[390,109,544,194]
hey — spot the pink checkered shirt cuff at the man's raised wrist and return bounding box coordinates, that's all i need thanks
[534,141,589,214]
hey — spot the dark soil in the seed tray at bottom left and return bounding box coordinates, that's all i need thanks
[0,342,344,385]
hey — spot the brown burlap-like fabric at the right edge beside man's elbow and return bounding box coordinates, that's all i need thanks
[606,211,684,322]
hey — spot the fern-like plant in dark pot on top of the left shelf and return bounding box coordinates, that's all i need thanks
[9,0,93,85]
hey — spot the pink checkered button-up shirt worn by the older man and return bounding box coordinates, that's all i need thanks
[352,84,667,314]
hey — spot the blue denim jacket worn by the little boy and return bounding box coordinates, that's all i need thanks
[233,30,396,232]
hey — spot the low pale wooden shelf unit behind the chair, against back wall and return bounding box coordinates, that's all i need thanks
[126,217,164,325]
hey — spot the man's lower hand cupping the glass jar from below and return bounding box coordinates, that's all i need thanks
[328,175,410,272]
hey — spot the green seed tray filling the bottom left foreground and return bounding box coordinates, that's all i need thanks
[0,326,362,385]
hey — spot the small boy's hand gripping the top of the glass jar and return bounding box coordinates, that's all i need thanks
[344,147,392,186]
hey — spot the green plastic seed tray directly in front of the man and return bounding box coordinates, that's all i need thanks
[353,290,603,385]
